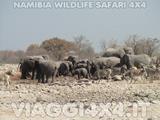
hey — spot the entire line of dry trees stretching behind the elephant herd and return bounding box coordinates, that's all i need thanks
[0,35,160,63]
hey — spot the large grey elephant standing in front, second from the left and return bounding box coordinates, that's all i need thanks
[34,60,58,83]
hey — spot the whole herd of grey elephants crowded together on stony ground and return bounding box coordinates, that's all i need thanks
[19,48,160,83]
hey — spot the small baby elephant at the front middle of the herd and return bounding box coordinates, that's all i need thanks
[74,68,89,79]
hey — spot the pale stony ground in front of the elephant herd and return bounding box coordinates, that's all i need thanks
[0,65,160,120]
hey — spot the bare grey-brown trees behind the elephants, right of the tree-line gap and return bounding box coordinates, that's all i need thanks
[101,35,160,57]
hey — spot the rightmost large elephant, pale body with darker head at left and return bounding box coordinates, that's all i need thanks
[120,54,151,69]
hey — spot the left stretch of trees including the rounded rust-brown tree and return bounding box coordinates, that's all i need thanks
[0,35,95,63]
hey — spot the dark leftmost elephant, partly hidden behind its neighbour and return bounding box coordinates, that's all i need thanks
[18,55,49,79]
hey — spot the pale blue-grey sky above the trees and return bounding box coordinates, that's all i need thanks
[0,0,160,50]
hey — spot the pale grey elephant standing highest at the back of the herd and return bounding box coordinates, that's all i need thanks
[102,47,134,58]
